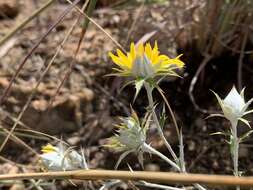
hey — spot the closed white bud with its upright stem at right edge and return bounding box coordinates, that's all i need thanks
[211,86,253,183]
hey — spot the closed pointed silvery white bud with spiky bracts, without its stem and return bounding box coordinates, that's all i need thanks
[214,86,253,125]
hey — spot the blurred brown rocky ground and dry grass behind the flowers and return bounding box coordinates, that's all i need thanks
[0,0,253,190]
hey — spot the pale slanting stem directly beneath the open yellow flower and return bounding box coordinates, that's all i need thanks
[144,83,178,163]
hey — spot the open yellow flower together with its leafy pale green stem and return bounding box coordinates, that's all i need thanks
[109,42,184,162]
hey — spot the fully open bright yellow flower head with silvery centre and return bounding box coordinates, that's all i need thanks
[109,42,184,79]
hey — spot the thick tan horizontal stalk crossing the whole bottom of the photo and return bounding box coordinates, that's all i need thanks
[0,170,253,187]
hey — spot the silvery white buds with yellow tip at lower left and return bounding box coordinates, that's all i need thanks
[40,144,84,171]
